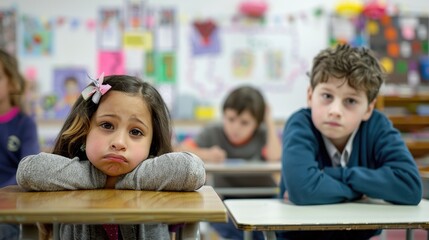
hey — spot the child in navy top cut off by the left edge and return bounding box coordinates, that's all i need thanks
[0,49,40,240]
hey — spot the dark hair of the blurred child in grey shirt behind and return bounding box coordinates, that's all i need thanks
[223,86,265,125]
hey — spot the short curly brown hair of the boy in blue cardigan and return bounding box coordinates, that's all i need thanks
[310,45,386,102]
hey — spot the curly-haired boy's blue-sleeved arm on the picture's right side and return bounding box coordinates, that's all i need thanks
[343,120,422,205]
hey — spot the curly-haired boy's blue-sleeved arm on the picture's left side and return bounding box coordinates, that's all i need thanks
[282,112,362,205]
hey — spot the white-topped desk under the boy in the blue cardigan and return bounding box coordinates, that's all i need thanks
[224,199,429,239]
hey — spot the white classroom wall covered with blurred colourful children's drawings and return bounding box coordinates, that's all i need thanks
[0,0,427,120]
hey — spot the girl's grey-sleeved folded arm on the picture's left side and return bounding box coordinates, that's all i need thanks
[16,153,106,191]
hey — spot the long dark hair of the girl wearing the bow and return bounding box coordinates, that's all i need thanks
[53,75,173,159]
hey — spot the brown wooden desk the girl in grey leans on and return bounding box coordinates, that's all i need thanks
[0,186,227,238]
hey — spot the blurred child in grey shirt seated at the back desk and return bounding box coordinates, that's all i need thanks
[178,86,281,239]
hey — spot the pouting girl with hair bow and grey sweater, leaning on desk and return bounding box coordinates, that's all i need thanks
[17,75,205,240]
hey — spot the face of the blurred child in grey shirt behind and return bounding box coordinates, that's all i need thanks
[223,108,258,145]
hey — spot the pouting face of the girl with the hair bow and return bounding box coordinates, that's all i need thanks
[86,91,153,177]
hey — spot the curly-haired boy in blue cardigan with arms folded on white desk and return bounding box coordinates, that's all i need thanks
[278,45,422,239]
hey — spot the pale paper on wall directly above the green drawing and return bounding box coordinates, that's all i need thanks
[155,8,177,52]
